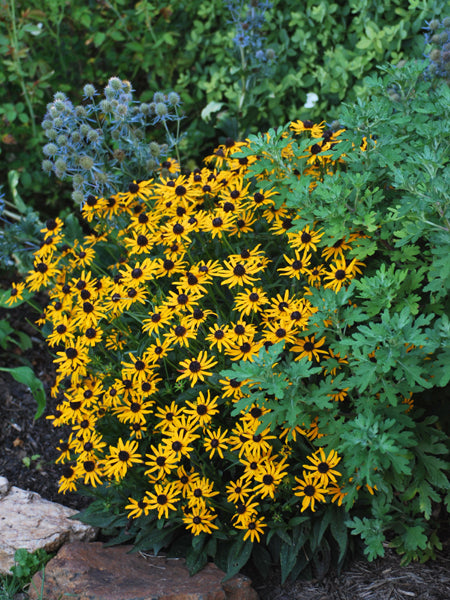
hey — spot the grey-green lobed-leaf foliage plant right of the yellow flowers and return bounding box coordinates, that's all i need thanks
[222,55,450,563]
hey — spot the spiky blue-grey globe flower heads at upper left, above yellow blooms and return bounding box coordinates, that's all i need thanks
[42,77,180,204]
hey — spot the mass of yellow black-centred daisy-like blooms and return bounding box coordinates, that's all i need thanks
[18,121,372,542]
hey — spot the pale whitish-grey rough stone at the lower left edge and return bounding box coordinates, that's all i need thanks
[0,477,97,575]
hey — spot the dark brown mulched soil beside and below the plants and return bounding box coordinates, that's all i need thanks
[0,282,450,600]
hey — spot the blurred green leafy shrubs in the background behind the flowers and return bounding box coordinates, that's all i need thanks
[0,0,445,216]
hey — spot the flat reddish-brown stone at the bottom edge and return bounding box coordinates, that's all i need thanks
[28,542,258,600]
